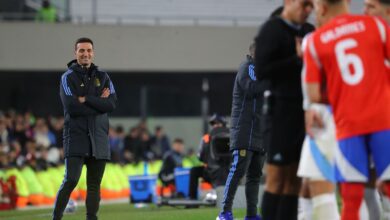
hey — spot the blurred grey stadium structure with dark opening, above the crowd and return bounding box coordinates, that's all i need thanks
[0,0,363,148]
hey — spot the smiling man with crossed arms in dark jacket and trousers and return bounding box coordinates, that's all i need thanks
[53,38,117,220]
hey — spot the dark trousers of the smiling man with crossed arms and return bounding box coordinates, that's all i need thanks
[53,157,106,220]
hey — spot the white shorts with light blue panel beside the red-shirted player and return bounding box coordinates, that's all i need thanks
[298,104,338,182]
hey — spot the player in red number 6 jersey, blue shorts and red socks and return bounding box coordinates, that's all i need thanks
[303,0,390,220]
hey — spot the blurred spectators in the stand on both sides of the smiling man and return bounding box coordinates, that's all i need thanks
[0,110,190,171]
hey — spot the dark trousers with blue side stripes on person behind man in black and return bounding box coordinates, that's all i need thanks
[222,150,265,216]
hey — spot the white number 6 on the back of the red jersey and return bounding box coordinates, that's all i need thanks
[335,38,364,86]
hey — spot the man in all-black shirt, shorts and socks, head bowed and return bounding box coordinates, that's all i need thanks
[255,0,314,220]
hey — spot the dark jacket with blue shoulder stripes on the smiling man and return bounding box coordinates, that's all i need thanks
[60,61,117,160]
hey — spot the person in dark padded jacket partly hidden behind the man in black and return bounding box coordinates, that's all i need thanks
[217,44,264,220]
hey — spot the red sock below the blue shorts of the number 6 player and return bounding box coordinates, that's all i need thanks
[340,183,364,220]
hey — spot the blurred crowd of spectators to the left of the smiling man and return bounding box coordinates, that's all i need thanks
[0,111,64,170]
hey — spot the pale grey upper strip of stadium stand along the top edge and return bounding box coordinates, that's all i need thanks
[70,0,363,26]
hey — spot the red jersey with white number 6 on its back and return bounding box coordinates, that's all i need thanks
[303,15,390,139]
